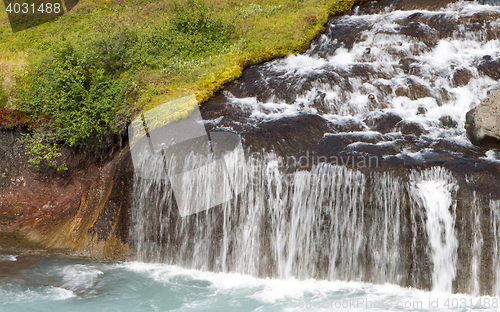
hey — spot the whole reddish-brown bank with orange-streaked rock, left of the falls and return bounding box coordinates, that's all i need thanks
[0,130,128,258]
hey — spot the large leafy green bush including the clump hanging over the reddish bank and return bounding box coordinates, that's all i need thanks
[22,41,134,168]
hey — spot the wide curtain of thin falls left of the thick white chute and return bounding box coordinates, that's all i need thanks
[130,150,410,283]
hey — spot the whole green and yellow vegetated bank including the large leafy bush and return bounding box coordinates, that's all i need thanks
[0,0,355,169]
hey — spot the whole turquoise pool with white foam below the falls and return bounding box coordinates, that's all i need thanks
[0,258,499,312]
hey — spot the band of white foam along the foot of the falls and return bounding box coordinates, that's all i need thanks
[120,262,500,311]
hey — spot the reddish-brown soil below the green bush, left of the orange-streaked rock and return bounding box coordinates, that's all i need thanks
[0,131,118,240]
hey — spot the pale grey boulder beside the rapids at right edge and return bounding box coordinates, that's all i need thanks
[465,90,500,148]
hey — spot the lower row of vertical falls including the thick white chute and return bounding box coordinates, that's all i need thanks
[126,147,484,292]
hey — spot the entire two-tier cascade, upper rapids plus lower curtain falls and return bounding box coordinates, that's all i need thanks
[129,2,500,295]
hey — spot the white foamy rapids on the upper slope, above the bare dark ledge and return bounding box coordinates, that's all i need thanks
[221,1,500,145]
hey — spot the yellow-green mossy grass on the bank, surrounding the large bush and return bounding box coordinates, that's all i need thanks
[0,0,356,166]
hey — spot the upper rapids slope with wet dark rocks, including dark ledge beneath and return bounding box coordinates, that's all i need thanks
[202,1,500,173]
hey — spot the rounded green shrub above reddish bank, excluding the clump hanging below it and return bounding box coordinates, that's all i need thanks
[25,42,134,146]
